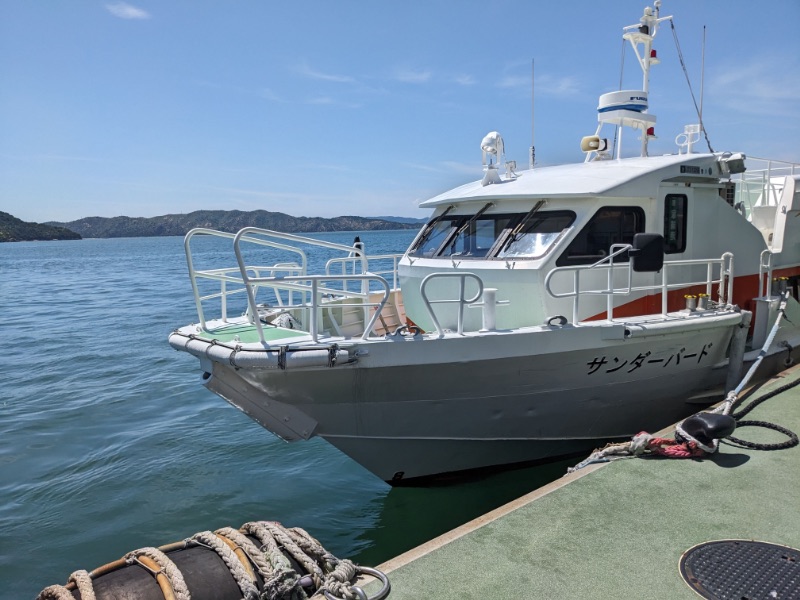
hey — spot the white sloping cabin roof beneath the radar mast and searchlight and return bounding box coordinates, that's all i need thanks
[420,154,721,208]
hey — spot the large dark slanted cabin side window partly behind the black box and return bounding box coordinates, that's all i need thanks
[556,206,644,266]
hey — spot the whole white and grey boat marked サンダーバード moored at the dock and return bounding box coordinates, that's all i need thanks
[169,0,800,485]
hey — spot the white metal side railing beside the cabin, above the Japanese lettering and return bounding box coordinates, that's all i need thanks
[544,244,733,323]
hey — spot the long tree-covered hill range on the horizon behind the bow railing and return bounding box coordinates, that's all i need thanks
[49,210,419,238]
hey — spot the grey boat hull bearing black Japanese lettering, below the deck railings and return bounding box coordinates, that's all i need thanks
[191,312,741,483]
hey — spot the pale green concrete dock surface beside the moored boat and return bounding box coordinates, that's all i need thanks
[366,366,800,600]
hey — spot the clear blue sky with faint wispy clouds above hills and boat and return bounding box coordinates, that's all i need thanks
[0,0,800,222]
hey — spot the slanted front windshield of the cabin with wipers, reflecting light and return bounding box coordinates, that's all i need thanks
[410,205,575,259]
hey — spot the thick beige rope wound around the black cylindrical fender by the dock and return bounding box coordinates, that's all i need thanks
[36,521,390,600]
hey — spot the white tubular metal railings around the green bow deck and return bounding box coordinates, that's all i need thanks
[184,227,398,343]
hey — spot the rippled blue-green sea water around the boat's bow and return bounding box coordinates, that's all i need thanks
[0,230,565,599]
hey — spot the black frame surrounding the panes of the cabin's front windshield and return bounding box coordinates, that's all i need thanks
[408,205,577,261]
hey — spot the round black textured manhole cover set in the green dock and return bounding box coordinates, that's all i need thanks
[680,540,800,600]
